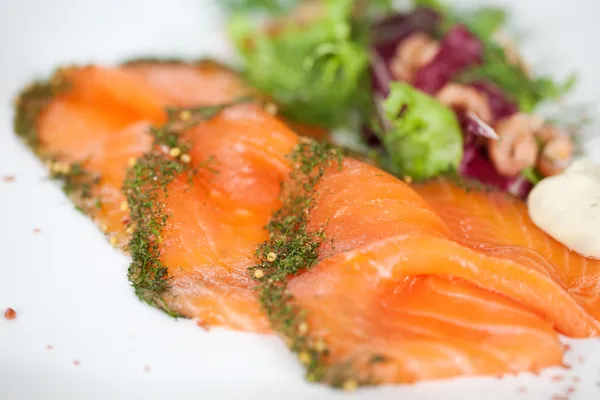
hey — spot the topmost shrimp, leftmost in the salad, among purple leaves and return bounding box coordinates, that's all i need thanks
[390,33,440,82]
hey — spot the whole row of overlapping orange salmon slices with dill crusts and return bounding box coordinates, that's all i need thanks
[12,62,600,388]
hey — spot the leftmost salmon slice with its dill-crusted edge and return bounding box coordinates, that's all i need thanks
[15,61,248,246]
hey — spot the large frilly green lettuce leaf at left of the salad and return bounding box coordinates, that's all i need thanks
[230,0,369,128]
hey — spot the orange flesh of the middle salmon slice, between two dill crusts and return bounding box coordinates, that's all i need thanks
[152,105,298,332]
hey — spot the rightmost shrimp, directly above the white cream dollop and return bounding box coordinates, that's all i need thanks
[536,125,575,176]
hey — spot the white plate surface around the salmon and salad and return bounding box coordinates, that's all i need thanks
[0,0,600,400]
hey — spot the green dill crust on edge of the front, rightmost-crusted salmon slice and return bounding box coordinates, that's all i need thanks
[249,140,376,389]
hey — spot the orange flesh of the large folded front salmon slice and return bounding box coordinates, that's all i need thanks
[280,159,600,384]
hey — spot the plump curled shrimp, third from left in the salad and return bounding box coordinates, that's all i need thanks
[488,113,539,177]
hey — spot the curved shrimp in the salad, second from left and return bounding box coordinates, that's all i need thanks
[437,83,492,124]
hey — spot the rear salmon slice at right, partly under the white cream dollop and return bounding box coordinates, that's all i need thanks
[416,180,600,320]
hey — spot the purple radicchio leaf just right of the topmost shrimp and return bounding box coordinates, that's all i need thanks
[414,25,483,94]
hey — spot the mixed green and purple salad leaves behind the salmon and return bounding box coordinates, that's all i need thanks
[221,0,575,194]
